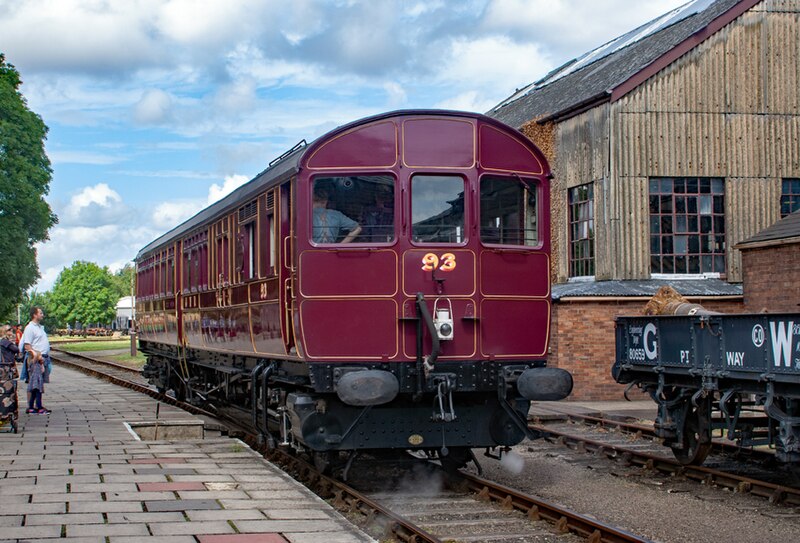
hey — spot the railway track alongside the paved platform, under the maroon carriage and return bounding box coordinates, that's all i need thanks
[52,349,647,543]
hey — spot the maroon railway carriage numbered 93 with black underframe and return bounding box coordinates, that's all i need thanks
[136,111,572,472]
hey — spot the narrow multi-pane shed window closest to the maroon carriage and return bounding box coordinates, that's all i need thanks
[568,183,594,277]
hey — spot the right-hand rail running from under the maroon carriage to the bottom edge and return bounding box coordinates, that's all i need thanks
[459,473,649,543]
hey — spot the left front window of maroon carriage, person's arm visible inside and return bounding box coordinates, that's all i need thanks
[311,175,395,243]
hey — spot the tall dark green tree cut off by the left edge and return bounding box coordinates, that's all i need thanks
[0,53,58,318]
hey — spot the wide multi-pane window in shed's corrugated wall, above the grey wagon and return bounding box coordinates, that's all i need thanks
[650,177,725,274]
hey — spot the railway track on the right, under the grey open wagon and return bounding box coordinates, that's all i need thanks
[529,421,800,506]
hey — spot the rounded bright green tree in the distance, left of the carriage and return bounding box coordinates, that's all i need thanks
[49,260,119,326]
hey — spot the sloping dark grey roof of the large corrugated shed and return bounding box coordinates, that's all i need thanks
[487,0,753,128]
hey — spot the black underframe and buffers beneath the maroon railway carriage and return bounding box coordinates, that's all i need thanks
[141,341,572,468]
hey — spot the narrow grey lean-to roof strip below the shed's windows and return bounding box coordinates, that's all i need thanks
[552,279,742,300]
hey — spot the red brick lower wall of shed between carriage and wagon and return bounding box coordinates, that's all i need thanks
[548,298,743,401]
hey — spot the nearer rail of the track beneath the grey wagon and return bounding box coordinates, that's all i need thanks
[529,424,800,505]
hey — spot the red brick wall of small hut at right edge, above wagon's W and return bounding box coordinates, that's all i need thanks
[742,243,800,313]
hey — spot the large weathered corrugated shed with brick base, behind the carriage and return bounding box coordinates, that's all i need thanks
[488,0,800,399]
